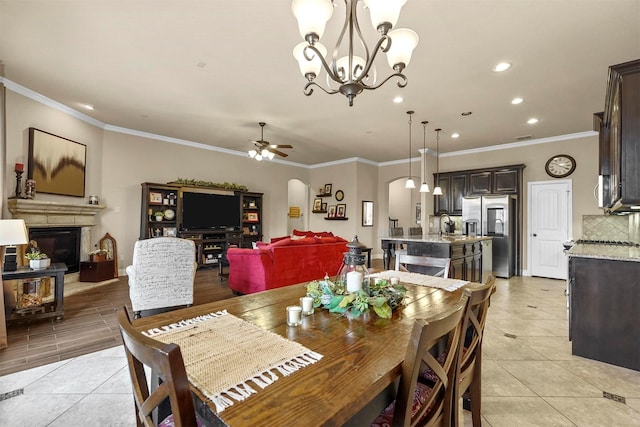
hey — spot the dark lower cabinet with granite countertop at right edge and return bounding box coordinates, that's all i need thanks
[567,244,640,370]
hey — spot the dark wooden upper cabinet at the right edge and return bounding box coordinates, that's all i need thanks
[600,60,640,211]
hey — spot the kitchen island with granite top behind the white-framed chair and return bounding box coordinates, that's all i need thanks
[381,234,492,282]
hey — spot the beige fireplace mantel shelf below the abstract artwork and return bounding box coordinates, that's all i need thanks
[7,199,106,227]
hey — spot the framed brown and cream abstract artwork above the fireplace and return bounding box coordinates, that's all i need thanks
[28,128,87,197]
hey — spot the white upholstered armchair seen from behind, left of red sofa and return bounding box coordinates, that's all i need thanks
[126,237,198,318]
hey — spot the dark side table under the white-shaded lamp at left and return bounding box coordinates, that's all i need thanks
[2,262,67,323]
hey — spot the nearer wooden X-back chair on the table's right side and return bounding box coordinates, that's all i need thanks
[371,295,469,427]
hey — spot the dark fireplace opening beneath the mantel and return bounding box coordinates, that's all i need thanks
[29,227,81,273]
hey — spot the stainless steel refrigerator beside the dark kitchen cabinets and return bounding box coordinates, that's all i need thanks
[462,196,516,278]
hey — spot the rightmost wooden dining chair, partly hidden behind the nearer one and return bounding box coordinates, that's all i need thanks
[453,275,496,427]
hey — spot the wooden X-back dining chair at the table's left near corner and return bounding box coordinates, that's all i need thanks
[116,307,203,427]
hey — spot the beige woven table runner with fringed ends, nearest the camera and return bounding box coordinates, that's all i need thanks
[143,310,322,413]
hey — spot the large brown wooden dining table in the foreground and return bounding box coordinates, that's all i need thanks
[133,273,469,426]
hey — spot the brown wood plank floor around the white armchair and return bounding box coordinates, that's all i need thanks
[0,268,233,376]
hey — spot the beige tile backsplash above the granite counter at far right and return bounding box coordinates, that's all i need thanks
[581,214,640,242]
